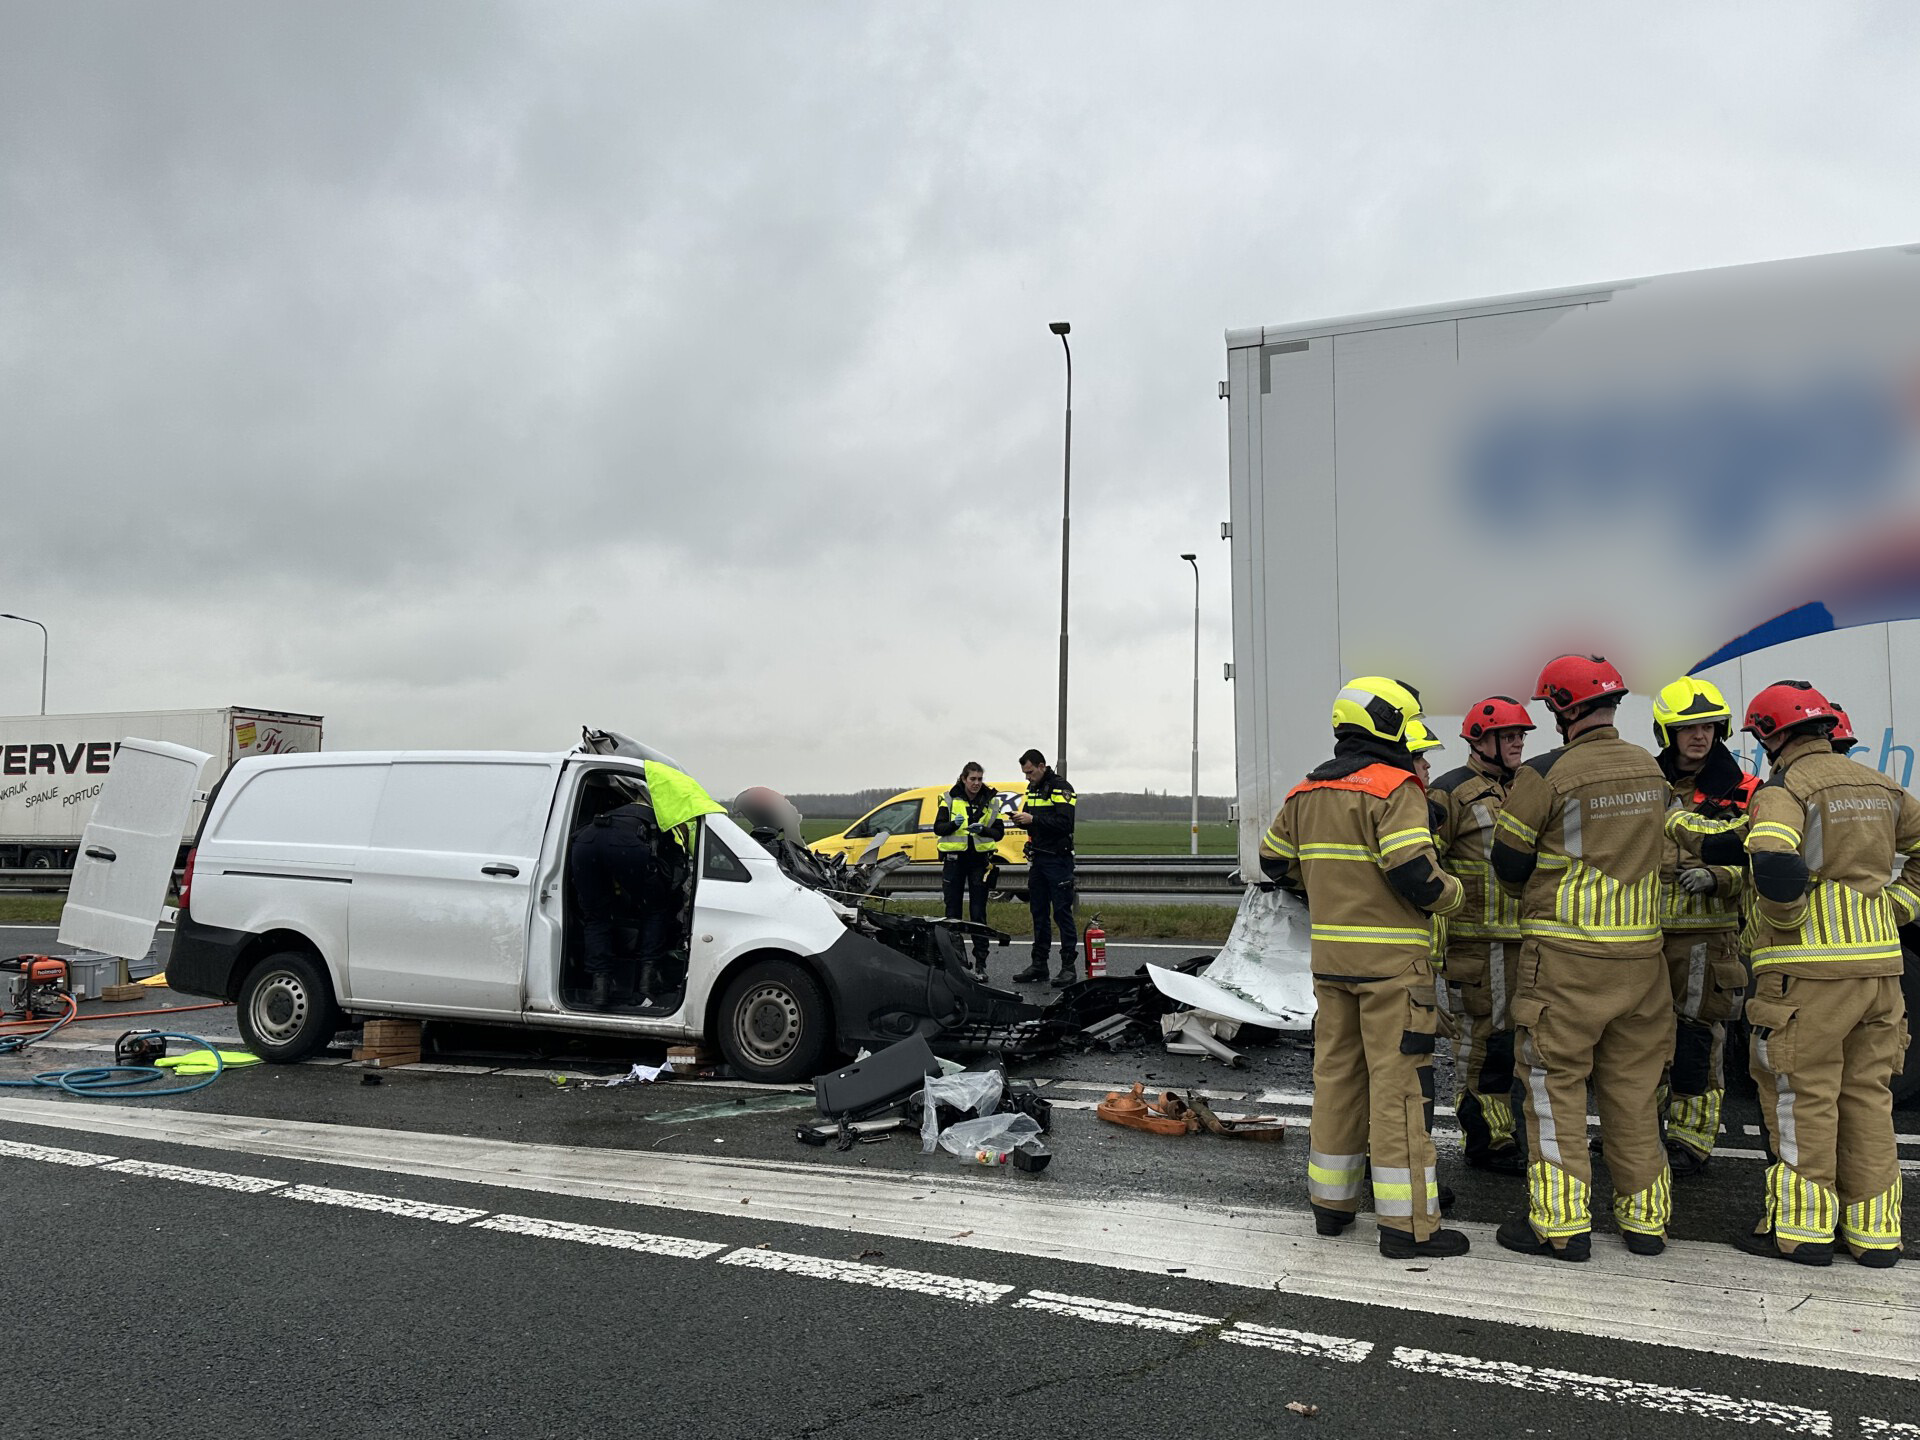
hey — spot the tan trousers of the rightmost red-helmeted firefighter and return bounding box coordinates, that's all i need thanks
[1747,970,1908,1254]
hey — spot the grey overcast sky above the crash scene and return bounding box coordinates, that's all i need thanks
[0,0,1920,793]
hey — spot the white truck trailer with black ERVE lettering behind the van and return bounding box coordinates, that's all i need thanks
[0,705,321,870]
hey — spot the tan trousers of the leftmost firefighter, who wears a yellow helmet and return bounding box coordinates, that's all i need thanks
[1308,960,1440,1240]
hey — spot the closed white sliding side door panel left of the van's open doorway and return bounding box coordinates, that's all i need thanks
[348,755,559,1018]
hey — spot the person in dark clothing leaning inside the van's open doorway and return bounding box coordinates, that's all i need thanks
[566,791,678,1010]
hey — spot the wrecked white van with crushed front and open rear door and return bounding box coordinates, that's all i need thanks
[61,735,1039,1081]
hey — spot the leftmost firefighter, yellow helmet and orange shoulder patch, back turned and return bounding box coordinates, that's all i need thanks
[1260,676,1467,1260]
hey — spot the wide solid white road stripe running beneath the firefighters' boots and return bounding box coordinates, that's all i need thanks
[0,1096,1920,1380]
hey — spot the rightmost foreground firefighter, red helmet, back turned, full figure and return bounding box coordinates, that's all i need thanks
[1734,680,1920,1267]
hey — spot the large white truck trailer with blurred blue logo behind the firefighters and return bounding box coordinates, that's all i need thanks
[1221,246,1920,1087]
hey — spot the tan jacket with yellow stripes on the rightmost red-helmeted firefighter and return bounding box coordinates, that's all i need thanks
[1745,735,1920,979]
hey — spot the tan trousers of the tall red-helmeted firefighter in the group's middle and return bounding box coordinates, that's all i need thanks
[1513,939,1672,1244]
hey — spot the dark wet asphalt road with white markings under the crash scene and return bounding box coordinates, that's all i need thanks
[0,931,1920,1440]
